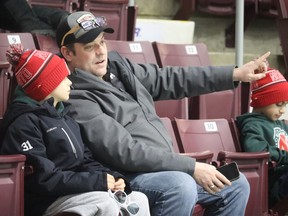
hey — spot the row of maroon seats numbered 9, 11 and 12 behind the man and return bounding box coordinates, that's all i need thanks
[0,33,250,123]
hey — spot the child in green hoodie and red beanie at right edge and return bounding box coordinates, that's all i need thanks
[237,68,288,207]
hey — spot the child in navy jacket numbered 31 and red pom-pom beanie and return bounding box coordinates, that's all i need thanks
[0,44,150,216]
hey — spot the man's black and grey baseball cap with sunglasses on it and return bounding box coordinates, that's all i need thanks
[56,11,114,47]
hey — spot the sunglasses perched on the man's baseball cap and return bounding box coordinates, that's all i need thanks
[61,17,107,46]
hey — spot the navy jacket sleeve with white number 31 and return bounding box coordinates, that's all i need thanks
[1,117,115,196]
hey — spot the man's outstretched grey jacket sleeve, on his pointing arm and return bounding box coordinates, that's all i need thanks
[117,55,239,101]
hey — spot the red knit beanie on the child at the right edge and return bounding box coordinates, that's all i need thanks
[250,68,288,108]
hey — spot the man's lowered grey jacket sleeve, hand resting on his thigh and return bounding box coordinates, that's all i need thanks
[70,95,195,175]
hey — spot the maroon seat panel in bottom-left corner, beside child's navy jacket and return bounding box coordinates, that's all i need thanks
[0,155,25,216]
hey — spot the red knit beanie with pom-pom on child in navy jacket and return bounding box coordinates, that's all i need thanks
[6,44,70,101]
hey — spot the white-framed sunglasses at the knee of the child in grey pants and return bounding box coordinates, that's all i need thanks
[108,190,139,216]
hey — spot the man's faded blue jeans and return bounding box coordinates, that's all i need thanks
[126,171,250,216]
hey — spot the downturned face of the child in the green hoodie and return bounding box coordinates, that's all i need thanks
[261,101,288,121]
